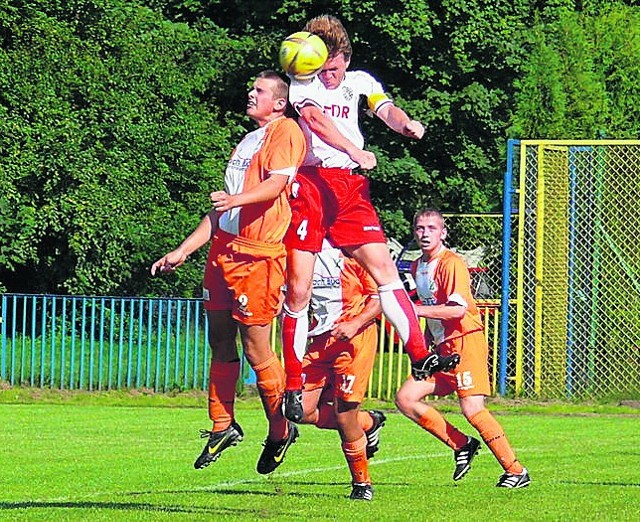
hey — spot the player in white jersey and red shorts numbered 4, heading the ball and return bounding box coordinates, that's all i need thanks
[282,15,456,421]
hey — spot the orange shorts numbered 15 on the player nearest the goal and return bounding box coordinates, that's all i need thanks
[429,330,491,397]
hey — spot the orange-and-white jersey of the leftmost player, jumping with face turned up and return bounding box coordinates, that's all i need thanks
[218,117,306,243]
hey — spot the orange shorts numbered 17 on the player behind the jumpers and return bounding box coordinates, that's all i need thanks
[302,323,378,403]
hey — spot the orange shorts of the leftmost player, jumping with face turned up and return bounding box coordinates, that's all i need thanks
[203,230,286,325]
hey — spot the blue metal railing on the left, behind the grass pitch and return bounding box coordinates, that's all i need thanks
[0,294,220,391]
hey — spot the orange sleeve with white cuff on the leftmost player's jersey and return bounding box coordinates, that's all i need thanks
[264,118,306,180]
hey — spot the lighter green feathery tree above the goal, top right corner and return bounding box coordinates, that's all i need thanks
[510,3,640,139]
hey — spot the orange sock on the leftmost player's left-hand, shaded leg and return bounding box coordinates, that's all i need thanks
[209,360,240,431]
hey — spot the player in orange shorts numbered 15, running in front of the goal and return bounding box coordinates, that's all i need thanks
[396,209,531,488]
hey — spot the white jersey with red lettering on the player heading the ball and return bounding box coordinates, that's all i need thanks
[289,71,391,169]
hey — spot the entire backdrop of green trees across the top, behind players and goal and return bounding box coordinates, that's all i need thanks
[0,0,640,296]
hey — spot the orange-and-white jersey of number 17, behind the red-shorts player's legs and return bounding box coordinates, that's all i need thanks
[309,242,378,337]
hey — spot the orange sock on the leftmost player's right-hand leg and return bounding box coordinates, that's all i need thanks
[253,354,288,441]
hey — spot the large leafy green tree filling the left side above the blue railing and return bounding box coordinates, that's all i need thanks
[0,0,242,294]
